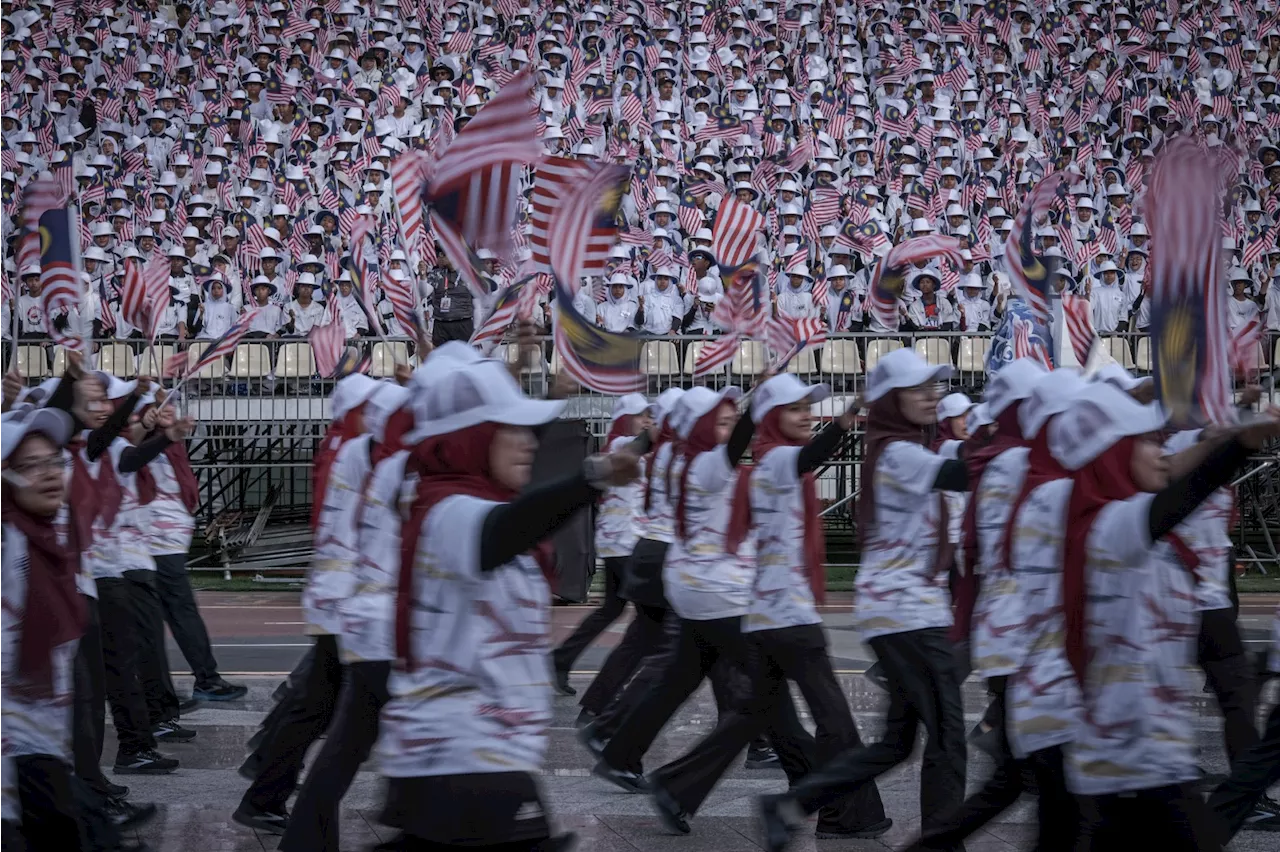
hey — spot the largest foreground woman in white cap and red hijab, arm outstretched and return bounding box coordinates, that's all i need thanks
[378,343,639,852]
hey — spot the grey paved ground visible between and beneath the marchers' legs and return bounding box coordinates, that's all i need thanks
[106,594,1280,852]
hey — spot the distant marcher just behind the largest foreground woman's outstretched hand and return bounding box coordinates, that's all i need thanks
[552,394,653,695]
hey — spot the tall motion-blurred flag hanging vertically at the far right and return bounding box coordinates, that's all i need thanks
[1144,137,1235,429]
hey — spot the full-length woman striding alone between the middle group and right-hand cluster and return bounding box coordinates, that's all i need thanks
[760,349,969,852]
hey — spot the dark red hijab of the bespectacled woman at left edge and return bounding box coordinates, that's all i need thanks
[0,484,84,700]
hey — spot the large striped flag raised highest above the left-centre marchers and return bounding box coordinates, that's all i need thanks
[422,72,541,298]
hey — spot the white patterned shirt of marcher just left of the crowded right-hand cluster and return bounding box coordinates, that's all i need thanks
[854,441,951,641]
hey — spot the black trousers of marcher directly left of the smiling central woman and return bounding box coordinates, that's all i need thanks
[603,615,808,793]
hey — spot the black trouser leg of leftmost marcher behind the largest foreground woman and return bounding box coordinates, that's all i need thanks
[241,636,342,814]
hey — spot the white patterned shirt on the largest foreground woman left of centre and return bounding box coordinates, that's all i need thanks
[378,495,552,778]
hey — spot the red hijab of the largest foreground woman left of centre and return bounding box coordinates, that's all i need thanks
[396,423,556,669]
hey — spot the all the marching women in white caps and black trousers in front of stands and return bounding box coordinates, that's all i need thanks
[0,330,1280,852]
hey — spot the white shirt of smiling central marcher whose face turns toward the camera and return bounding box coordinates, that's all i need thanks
[742,446,822,632]
